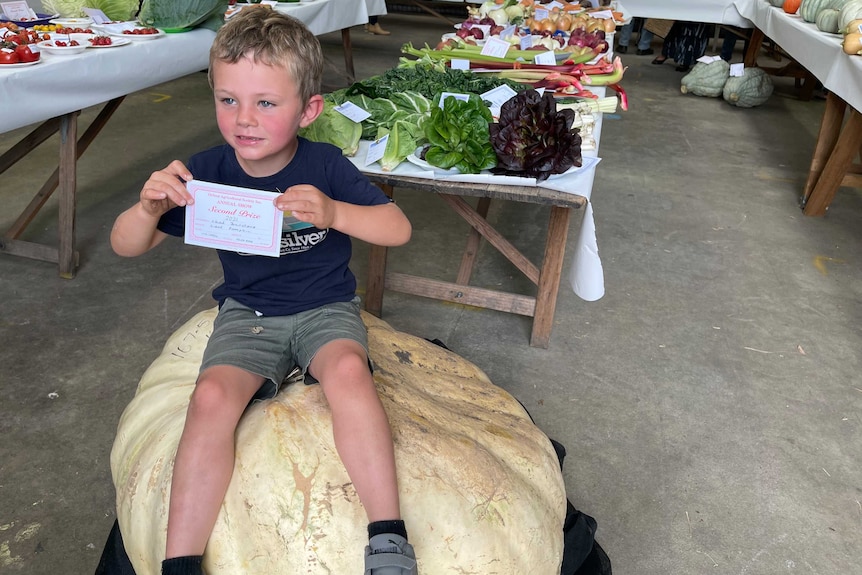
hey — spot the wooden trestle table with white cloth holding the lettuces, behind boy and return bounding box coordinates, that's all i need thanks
[351,102,605,348]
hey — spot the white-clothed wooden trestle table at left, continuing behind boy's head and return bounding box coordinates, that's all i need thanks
[0,0,386,278]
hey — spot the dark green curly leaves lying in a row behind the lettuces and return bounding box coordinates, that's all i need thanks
[347,59,526,99]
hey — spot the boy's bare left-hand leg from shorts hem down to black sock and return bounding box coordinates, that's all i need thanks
[165,366,263,559]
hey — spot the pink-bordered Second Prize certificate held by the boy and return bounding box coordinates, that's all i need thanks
[185,180,284,257]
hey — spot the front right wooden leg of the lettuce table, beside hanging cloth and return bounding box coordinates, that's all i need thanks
[530,206,572,349]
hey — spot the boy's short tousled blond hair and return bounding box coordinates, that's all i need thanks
[209,7,323,104]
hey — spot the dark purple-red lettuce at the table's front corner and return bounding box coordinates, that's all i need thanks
[490,88,581,182]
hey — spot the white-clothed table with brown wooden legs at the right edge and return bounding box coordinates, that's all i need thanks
[734,0,862,216]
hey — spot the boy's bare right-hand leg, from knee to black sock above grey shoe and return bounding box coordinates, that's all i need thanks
[309,339,401,522]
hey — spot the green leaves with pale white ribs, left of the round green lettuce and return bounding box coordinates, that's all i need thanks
[324,88,431,172]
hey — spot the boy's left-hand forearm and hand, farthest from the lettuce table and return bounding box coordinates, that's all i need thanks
[111,161,194,257]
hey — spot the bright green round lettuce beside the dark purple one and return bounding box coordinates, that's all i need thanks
[425,94,497,174]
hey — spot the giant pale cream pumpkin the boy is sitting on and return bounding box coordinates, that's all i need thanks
[111,310,566,575]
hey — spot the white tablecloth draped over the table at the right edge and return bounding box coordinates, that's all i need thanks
[734,0,862,111]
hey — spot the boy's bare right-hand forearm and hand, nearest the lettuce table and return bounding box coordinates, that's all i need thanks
[275,184,412,246]
